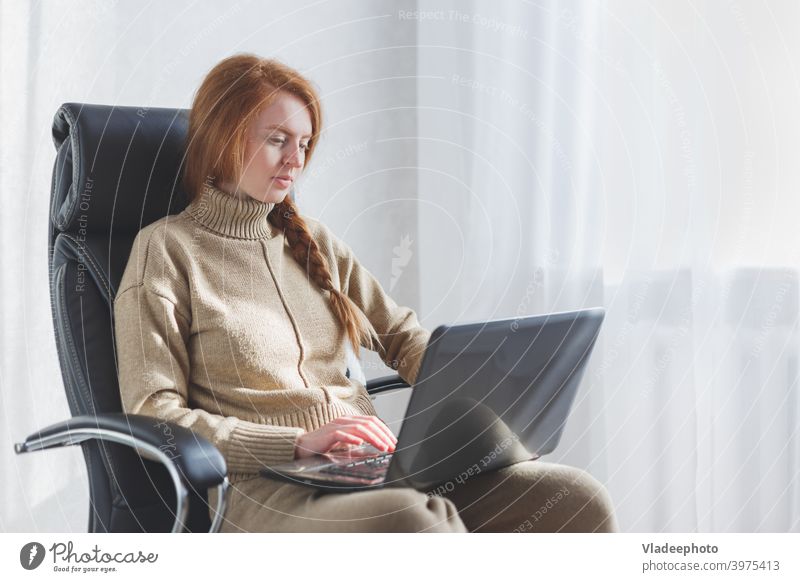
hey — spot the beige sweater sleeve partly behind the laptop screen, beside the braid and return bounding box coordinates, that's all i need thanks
[319,223,431,385]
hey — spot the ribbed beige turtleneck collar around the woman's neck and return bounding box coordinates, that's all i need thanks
[186,184,277,240]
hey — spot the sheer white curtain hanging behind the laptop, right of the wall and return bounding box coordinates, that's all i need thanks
[418,0,800,532]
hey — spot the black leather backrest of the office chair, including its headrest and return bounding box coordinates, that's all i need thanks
[49,103,203,531]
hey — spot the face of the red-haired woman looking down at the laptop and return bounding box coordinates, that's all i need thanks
[220,91,312,203]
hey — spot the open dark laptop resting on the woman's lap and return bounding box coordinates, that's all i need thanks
[261,308,605,493]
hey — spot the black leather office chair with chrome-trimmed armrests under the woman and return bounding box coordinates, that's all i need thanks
[15,103,408,532]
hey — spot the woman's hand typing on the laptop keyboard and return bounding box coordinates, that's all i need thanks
[294,415,397,459]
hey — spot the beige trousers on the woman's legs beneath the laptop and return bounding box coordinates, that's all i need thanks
[212,461,617,532]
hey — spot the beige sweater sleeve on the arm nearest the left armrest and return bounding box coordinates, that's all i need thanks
[114,226,305,473]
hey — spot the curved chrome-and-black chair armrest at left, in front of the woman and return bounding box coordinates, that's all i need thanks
[14,413,228,532]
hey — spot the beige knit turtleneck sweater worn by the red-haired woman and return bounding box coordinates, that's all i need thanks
[114,186,430,474]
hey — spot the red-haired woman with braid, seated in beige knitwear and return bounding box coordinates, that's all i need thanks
[114,54,616,532]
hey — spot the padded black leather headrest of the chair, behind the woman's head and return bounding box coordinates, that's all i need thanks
[50,103,189,237]
